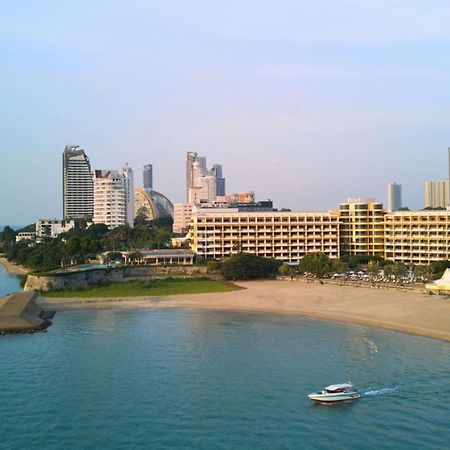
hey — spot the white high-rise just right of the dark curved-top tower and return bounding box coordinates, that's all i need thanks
[94,166,134,228]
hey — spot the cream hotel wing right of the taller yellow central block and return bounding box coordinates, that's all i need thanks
[384,211,450,265]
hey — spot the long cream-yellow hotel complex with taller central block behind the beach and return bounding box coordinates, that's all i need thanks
[189,199,450,265]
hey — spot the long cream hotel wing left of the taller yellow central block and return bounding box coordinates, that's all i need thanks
[188,209,340,264]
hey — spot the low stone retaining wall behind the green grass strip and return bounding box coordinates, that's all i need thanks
[24,266,207,292]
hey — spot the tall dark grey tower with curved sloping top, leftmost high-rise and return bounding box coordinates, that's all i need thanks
[63,145,94,221]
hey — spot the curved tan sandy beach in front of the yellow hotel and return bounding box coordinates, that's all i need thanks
[38,281,450,341]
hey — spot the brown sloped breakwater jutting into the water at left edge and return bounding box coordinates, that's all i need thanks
[0,292,51,334]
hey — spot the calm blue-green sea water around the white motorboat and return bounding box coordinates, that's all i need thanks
[0,268,450,450]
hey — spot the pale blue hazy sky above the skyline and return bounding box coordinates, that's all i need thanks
[0,0,450,224]
